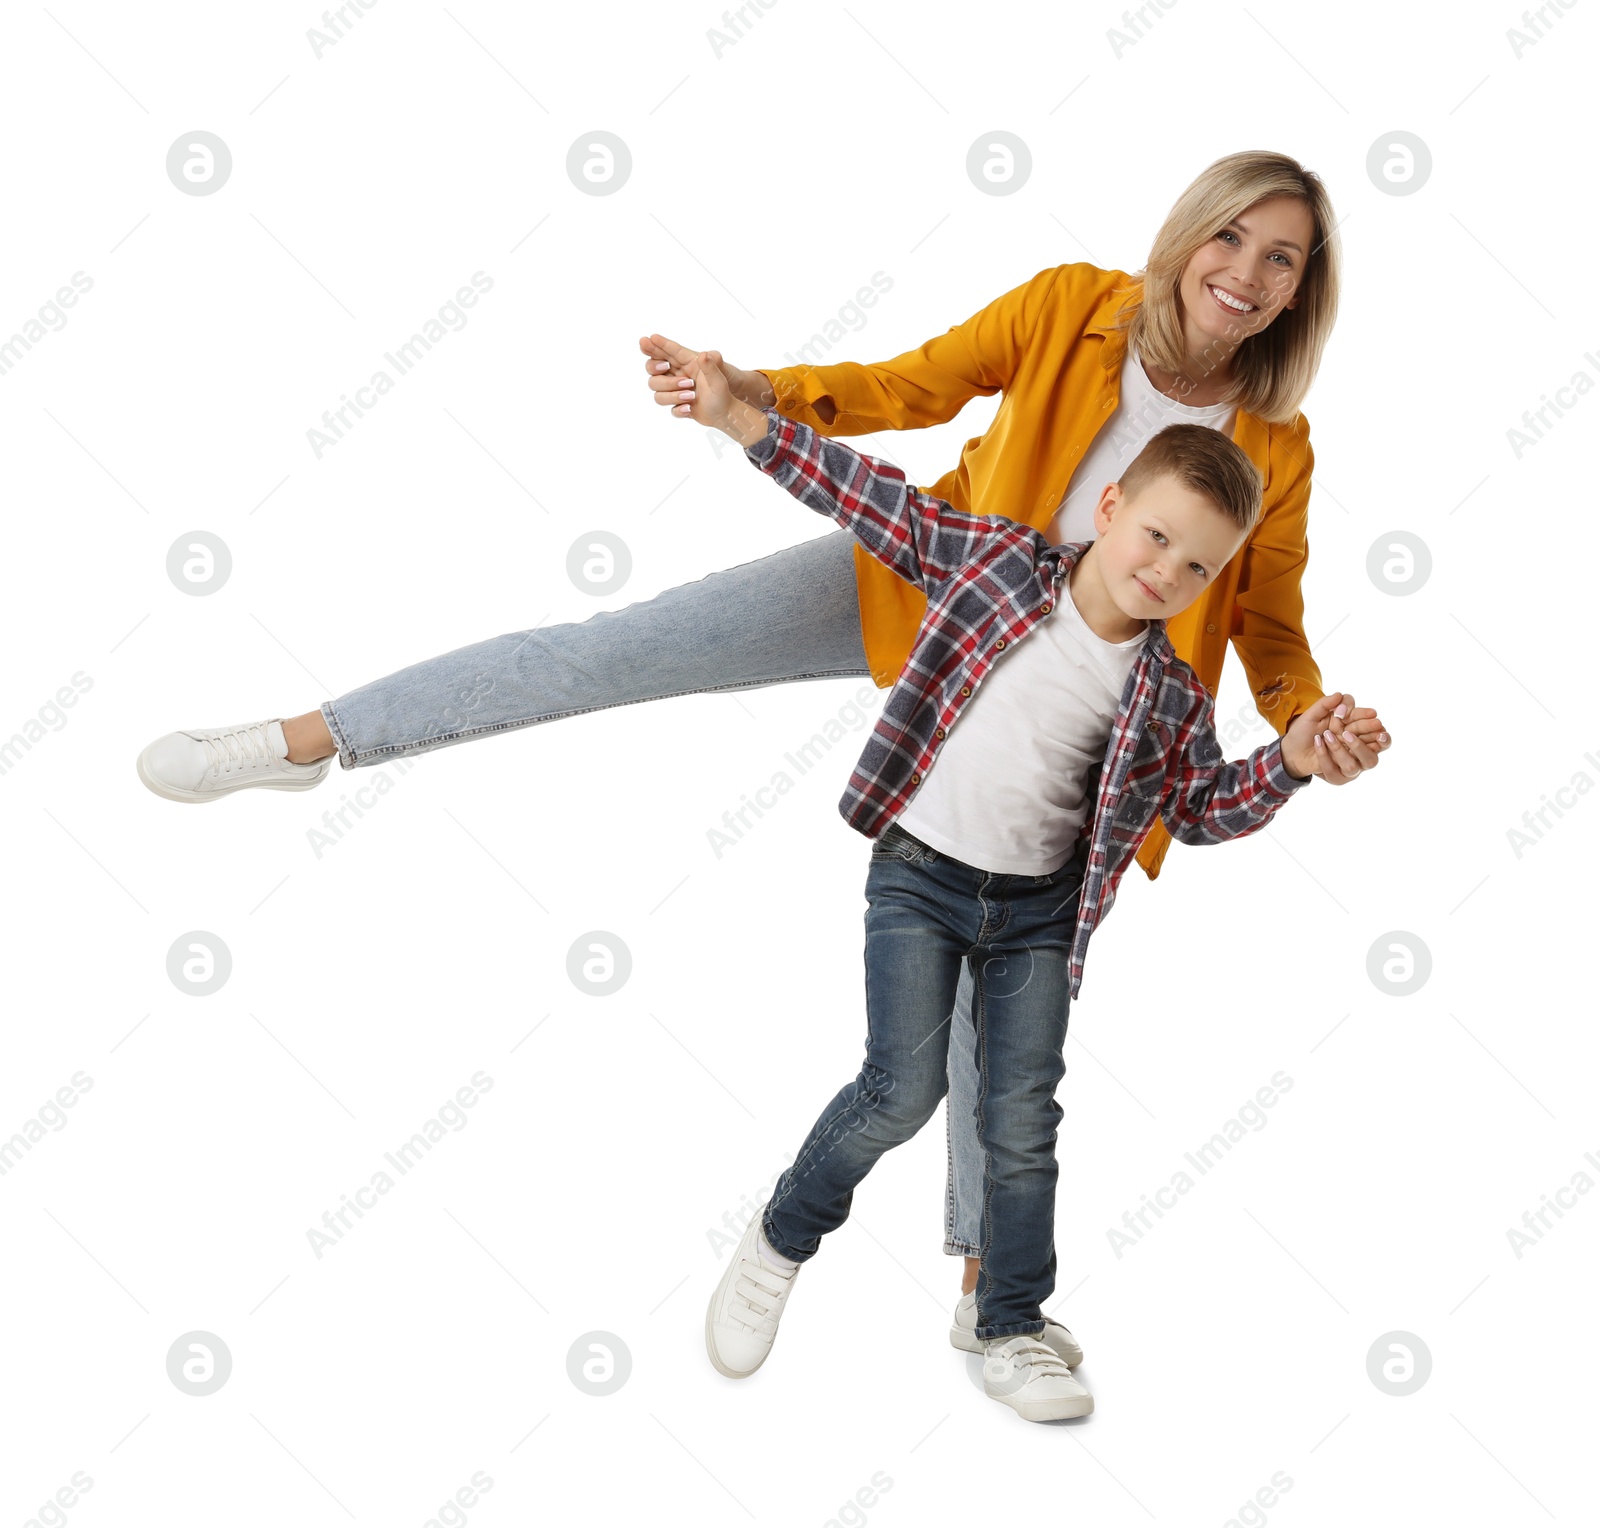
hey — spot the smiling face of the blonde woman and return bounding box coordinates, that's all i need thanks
[1178,197,1315,354]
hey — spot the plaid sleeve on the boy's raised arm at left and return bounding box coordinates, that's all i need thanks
[744,408,992,590]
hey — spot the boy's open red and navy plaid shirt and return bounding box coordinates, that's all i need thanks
[744,408,1310,997]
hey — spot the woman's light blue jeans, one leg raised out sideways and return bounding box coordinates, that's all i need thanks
[322,530,1011,1258]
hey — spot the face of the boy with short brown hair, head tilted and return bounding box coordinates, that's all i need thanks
[1094,477,1248,621]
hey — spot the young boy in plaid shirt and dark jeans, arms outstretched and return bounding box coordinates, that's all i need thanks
[682,352,1350,1421]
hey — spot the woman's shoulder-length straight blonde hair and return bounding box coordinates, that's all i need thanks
[1117,149,1341,424]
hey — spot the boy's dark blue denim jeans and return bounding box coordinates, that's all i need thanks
[762,824,1083,1338]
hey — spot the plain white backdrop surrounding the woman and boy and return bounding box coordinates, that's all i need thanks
[0,0,1600,1528]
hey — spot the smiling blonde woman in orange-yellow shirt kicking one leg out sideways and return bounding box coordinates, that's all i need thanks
[139,152,1390,1346]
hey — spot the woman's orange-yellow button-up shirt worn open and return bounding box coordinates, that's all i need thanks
[765,264,1323,880]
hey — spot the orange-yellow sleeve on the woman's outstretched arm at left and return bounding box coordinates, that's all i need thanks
[744,266,1062,435]
